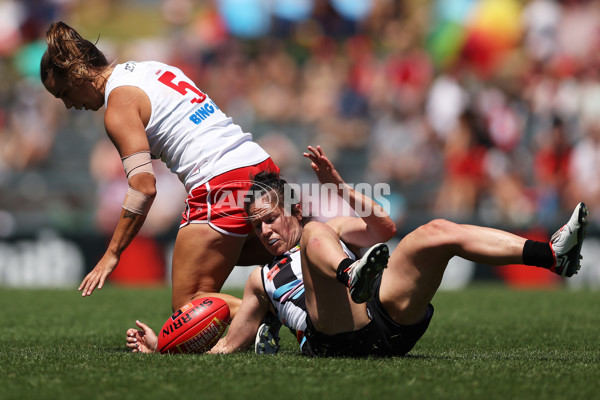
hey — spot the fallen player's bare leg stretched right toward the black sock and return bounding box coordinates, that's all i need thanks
[379,220,526,325]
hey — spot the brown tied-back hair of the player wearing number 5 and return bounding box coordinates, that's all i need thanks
[40,21,108,85]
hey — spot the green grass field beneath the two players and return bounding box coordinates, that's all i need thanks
[0,286,600,400]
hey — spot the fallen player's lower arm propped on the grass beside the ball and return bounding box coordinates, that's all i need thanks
[209,268,270,354]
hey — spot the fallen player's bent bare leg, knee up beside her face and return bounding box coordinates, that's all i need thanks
[300,222,369,335]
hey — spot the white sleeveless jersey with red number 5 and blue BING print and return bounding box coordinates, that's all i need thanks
[105,61,269,192]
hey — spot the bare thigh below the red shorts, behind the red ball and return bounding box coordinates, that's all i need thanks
[172,224,246,317]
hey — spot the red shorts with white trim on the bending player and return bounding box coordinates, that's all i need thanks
[180,158,279,236]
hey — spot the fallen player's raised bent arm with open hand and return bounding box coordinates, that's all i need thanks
[303,146,396,247]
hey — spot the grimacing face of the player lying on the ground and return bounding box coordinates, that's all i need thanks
[250,195,302,256]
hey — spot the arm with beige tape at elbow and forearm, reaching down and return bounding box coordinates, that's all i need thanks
[79,86,156,296]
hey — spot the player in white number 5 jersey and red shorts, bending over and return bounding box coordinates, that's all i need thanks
[41,22,279,315]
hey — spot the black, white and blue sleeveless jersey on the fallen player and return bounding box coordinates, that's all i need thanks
[261,240,356,343]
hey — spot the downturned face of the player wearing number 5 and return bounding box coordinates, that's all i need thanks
[44,73,104,111]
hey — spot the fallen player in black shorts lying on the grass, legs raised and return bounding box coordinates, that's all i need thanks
[127,147,588,357]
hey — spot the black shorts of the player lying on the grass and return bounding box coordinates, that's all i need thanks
[302,277,433,357]
